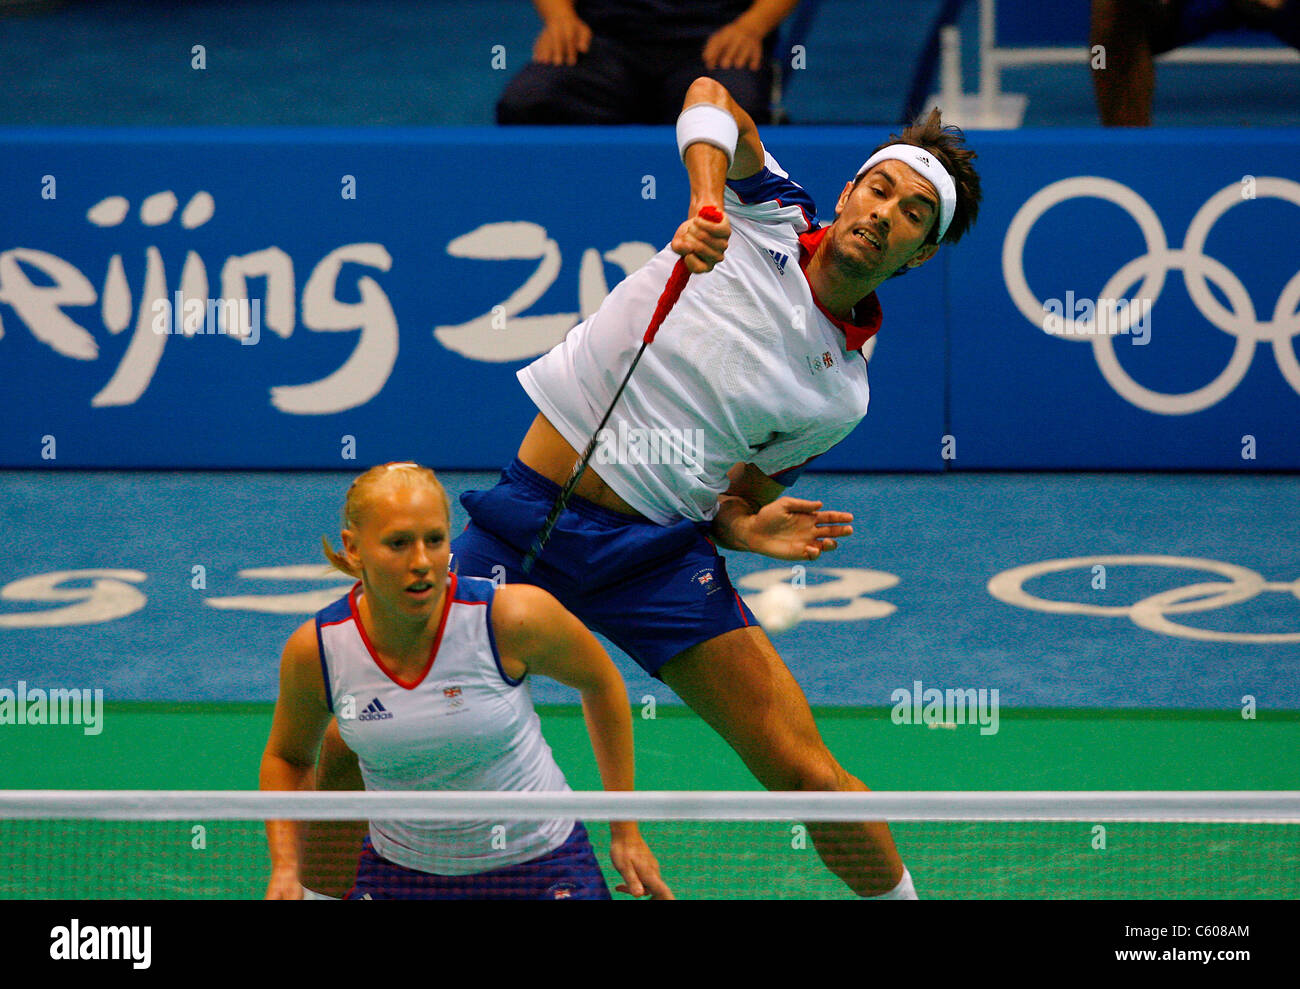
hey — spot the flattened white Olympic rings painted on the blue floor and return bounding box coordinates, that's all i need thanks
[988,555,1300,643]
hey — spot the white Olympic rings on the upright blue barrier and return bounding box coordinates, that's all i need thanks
[1002,175,1300,416]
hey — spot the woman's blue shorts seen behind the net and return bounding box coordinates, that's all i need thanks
[343,821,611,899]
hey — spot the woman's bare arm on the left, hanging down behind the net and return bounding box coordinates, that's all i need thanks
[259,621,330,899]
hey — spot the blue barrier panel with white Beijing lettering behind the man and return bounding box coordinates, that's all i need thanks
[0,129,944,470]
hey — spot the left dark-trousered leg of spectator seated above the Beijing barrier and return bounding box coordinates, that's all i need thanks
[497,35,647,123]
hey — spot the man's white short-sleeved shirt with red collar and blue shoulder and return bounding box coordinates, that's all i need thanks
[519,146,880,525]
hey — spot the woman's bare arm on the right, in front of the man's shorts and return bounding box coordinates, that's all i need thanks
[493,584,672,899]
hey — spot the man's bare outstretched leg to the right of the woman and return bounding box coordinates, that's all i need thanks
[659,626,904,897]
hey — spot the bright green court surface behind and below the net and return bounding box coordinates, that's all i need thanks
[0,703,1300,899]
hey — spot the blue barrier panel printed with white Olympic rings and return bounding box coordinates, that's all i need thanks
[949,131,1300,469]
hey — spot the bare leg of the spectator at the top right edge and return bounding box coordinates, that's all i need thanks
[1091,0,1156,127]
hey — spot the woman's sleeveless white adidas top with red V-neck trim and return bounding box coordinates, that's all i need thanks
[316,574,573,876]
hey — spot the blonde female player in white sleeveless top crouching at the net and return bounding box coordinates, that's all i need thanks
[261,463,672,899]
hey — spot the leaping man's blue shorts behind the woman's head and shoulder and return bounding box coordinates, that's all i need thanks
[451,460,758,677]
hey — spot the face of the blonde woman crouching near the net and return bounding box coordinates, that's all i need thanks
[343,485,451,617]
